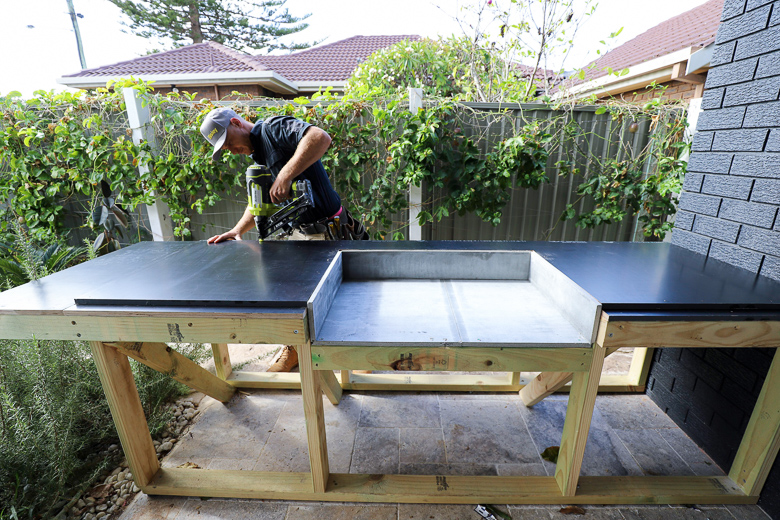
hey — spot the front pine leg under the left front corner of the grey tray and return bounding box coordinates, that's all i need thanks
[298,342,330,493]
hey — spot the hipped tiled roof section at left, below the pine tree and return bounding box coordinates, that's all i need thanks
[64,42,267,78]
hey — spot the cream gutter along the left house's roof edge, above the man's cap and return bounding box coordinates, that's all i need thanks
[57,70,298,94]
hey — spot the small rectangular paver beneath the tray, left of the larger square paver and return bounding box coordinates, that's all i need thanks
[358,392,441,428]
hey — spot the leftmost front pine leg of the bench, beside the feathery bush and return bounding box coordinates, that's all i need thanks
[90,341,160,487]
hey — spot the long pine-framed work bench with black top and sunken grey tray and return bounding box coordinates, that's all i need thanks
[0,241,780,504]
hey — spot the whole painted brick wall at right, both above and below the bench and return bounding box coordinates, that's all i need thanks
[647,0,780,518]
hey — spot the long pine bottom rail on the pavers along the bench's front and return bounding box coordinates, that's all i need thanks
[143,468,758,504]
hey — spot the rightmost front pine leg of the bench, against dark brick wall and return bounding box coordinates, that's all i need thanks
[729,350,780,496]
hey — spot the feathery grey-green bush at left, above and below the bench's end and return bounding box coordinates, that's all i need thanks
[0,226,206,519]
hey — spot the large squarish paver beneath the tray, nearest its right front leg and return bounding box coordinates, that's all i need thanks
[441,401,540,464]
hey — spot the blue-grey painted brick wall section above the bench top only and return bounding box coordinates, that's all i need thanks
[672,0,780,280]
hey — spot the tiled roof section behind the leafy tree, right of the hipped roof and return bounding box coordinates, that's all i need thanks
[251,34,420,81]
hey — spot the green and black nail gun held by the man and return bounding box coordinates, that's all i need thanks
[246,164,314,242]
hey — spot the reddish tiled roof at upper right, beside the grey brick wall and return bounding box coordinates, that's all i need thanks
[574,0,723,83]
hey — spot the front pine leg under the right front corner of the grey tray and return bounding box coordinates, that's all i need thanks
[555,344,606,496]
